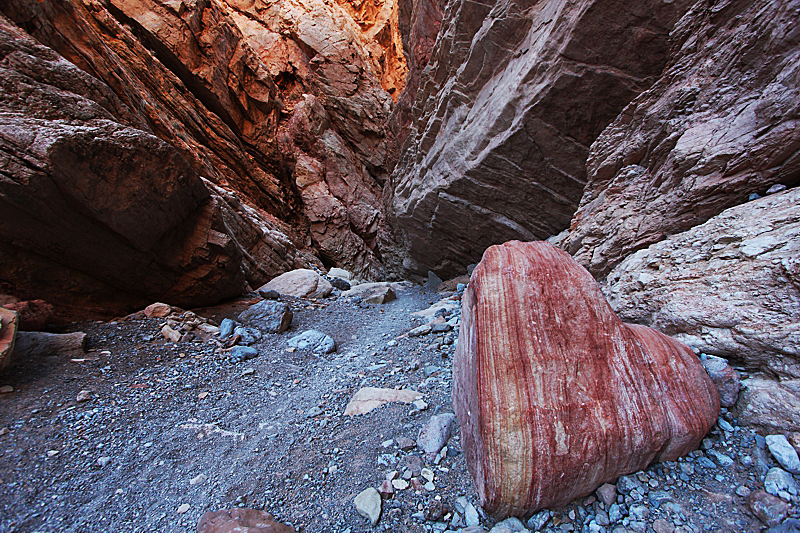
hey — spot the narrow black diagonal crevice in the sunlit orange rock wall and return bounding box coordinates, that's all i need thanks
[106,3,241,138]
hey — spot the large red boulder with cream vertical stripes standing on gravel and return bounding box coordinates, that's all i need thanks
[453,241,719,517]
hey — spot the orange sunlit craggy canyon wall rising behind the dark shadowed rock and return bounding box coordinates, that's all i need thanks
[0,0,406,290]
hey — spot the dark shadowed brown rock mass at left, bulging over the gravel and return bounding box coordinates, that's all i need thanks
[0,19,312,319]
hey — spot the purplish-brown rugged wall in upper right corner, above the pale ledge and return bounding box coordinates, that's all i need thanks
[562,0,800,277]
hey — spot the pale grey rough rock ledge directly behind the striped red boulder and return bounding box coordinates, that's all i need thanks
[603,189,800,378]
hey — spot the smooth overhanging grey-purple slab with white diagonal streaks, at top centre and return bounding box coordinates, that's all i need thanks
[388,0,688,277]
